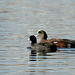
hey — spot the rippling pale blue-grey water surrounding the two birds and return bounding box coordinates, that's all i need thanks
[0,0,75,75]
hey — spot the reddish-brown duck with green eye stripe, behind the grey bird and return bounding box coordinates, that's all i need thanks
[37,30,75,48]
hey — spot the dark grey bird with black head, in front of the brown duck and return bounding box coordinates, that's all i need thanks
[29,35,57,53]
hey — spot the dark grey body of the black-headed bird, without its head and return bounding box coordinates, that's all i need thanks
[31,42,57,52]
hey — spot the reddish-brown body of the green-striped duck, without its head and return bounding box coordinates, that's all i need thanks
[40,38,75,48]
